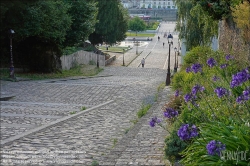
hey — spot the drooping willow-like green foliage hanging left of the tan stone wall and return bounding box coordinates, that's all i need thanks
[176,0,218,50]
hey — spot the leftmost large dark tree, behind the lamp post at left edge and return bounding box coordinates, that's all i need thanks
[0,0,72,71]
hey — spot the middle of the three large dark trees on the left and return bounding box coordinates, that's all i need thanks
[64,0,98,46]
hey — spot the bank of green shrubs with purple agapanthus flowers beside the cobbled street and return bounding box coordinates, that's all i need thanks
[150,47,250,165]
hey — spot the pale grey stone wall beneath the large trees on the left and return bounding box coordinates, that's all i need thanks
[60,50,105,70]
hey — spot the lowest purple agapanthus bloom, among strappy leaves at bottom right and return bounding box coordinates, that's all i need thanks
[207,140,226,156]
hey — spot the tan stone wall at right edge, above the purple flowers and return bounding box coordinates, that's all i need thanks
[219,19,250,62]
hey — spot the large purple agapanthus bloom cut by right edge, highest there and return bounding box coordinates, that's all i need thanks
[230,67,250,88]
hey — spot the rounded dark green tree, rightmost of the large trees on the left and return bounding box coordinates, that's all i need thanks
[89,0,127,44]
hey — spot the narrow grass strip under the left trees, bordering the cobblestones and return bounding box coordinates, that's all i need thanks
[1,65,103,80]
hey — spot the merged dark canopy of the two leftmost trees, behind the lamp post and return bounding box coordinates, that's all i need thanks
[0,0,97,71]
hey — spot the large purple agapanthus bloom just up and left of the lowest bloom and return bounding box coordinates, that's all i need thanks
[177,124,198,140]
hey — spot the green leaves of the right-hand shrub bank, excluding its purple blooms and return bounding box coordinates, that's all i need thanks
[165,47,250,165]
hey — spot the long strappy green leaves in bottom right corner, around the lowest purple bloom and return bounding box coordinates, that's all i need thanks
[181,120,250,166]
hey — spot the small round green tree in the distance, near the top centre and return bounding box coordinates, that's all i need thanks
[128,17,147,35]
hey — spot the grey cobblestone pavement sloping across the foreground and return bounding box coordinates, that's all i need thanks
[1,67,174,166]
